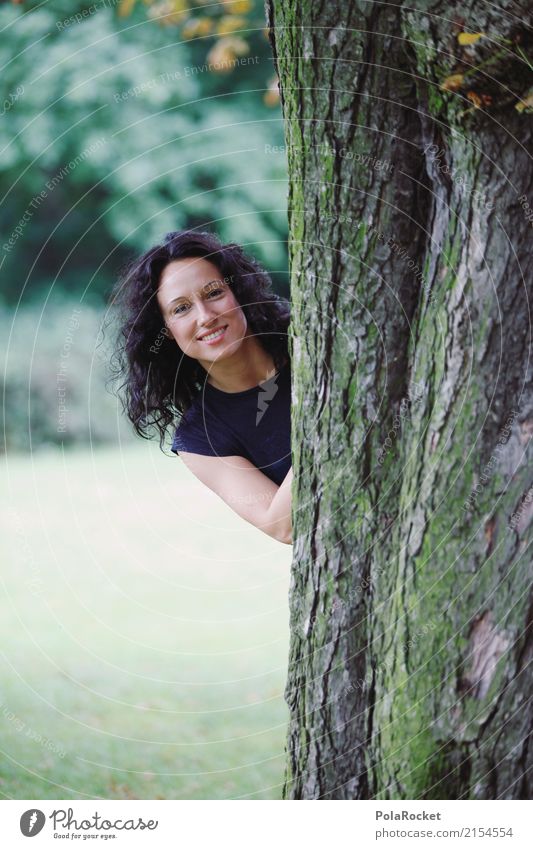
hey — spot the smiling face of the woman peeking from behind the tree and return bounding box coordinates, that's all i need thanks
[157,257,247,370]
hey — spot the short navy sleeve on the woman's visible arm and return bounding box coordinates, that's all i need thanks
[171,406,243,457]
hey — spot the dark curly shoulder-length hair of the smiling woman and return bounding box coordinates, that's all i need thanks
[110,225,290,449]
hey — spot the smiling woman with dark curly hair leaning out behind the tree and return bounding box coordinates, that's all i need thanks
[109,231,292,545]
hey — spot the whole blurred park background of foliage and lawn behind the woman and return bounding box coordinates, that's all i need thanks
[0,0,291,799]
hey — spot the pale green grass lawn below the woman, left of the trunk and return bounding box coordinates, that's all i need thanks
[0,442,292,799]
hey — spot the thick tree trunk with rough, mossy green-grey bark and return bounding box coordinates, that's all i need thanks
[267,0,533,799]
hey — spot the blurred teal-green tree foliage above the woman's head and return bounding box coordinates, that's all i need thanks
[0,0,286,302]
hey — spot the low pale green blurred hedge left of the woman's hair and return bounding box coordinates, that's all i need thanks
[0,299,134,453]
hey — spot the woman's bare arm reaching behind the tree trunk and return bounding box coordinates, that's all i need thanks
[179,451,292,545]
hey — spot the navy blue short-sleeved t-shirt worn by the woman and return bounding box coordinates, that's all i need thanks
[171,362,292,486]
